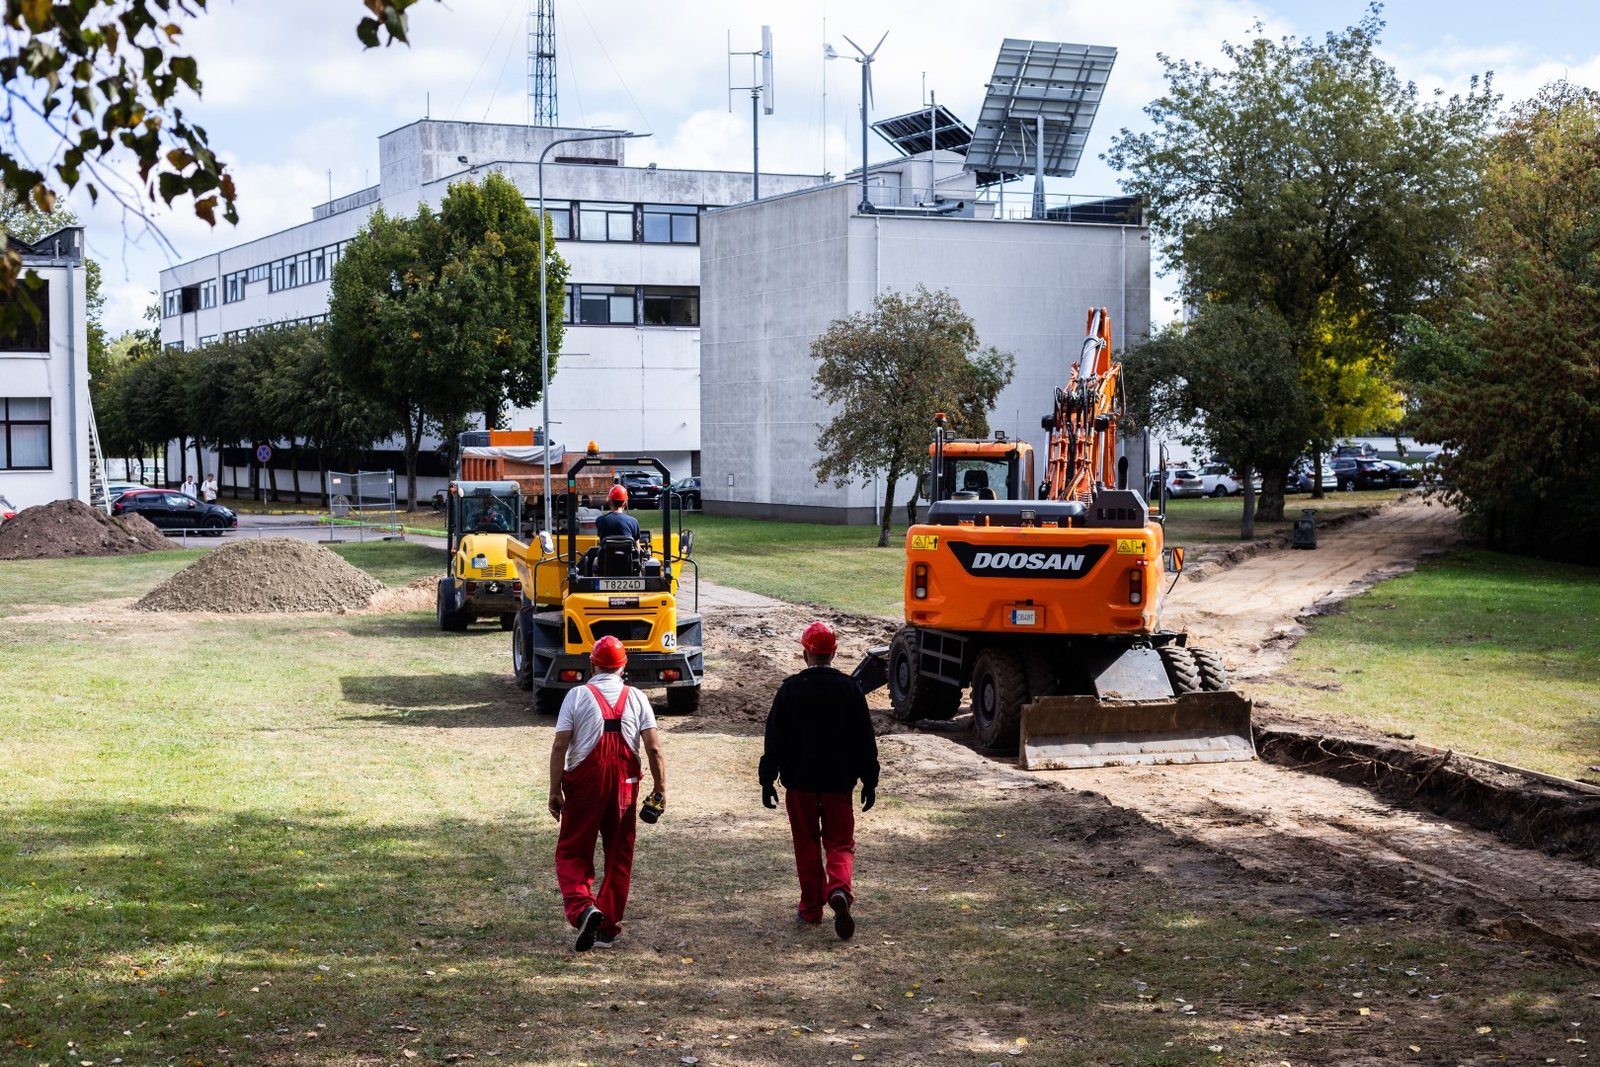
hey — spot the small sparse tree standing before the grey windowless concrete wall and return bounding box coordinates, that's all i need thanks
[811,285,1016,547]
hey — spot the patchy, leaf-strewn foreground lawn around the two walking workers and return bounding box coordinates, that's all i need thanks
[0,537,1595,1067]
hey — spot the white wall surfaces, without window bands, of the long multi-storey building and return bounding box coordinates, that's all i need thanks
[162,122,821,494]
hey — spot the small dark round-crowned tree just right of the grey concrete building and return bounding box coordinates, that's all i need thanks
[1123,304,1307,541]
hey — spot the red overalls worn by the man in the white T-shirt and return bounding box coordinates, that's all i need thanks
[555,685,640,937]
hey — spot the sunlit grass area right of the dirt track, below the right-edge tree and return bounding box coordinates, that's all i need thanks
[1258,550,1600,779]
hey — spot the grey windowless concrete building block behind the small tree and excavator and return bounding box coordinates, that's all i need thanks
[701,154,1150,523]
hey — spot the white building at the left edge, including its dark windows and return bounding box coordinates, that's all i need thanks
[0,226,91,510]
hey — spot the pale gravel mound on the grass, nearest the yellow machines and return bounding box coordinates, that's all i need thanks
[134,537,384,613]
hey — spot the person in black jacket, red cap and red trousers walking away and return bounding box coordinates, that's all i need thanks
[760,622,878,941]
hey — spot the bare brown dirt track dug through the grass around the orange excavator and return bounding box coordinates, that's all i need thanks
[677,498,1600,965]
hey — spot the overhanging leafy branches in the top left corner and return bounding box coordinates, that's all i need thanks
[0,0,428,334]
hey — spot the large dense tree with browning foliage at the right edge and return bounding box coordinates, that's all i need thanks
[1398,82,1600,563]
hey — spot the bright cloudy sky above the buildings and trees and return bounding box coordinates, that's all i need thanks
[40,0,1600,336]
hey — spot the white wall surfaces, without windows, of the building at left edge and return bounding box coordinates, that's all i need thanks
[0,227,90,510]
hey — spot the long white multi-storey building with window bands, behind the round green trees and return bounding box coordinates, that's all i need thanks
[162,120,822,496]
